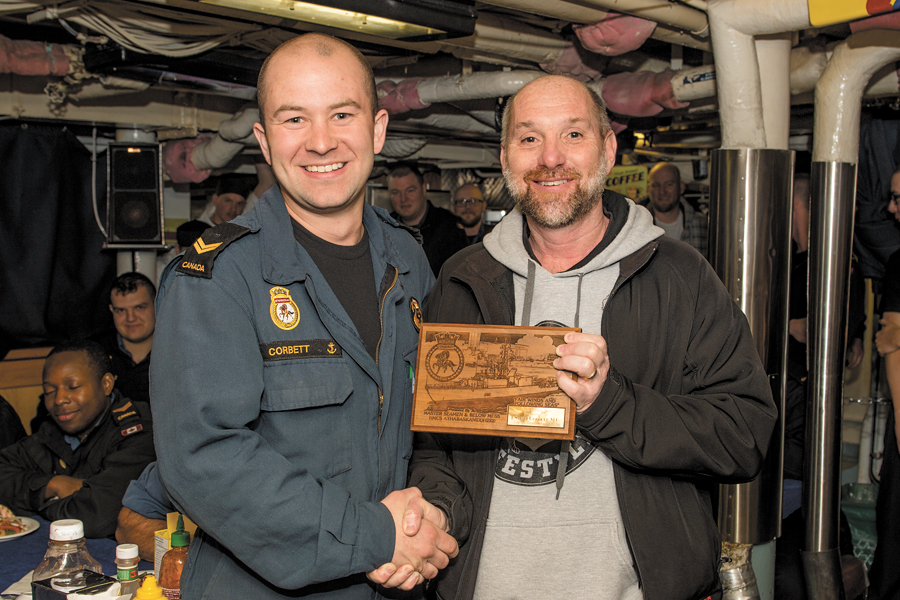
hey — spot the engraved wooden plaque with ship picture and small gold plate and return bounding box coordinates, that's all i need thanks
[412,323,580,440]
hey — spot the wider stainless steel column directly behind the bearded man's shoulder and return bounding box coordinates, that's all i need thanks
[709,149,794,544]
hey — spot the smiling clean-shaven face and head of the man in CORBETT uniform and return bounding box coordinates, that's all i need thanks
[253,35,388,219]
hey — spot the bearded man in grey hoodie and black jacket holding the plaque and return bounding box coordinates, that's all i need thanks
[394,76,776,600]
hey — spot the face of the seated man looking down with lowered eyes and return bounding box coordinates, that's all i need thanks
[43,352,115,436]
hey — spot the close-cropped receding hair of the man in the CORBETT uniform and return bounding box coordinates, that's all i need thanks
[256,33,378,127]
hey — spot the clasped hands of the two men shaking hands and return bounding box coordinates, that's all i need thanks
[366,488,459,590]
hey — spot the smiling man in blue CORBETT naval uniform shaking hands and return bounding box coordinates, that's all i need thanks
[151,34,457,600]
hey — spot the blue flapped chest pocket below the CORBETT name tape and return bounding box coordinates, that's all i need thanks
[256,359,353,478]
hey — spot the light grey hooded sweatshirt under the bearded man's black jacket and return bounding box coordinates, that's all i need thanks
[475,200,663,600]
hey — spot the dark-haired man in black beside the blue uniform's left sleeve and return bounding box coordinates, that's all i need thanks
[97,273,156,402]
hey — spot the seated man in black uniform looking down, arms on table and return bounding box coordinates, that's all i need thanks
[0,340,156,537]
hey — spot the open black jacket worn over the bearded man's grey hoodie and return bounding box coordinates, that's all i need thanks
[409,207,776,600]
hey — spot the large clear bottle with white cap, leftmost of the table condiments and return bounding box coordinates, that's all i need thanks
[32,519,103,591]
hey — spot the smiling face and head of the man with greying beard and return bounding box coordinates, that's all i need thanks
[500,76,616,229]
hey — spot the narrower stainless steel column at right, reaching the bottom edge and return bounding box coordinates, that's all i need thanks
[802,162,856,600]
